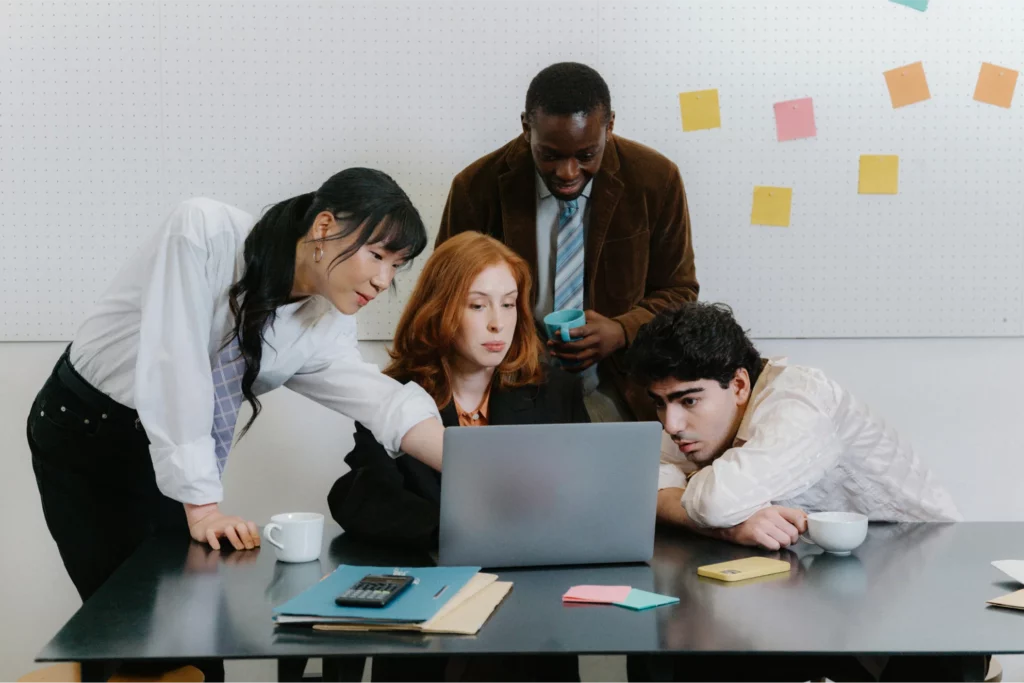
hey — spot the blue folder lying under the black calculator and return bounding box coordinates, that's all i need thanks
[273,564,480,624]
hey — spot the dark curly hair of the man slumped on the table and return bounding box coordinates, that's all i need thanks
[627,301,761,389]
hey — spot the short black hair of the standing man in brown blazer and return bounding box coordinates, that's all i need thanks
[526,61,611,123]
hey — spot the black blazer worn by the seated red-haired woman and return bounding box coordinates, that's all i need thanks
[327,368,590,550]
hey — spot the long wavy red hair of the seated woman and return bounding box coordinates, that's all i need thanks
[384,231,544,409]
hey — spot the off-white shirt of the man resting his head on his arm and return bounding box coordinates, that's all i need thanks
[658,359,961,528]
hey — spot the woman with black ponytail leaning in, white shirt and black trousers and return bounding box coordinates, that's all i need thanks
[28,168,443,600]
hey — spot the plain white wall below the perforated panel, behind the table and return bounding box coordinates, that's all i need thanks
[0,339,1024,681]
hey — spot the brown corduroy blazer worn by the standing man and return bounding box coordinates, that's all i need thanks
[435,135,699,420]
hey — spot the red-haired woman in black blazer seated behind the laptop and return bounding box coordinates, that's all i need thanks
[328,232,590,683]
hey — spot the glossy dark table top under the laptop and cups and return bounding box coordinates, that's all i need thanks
[39,522,1024,661]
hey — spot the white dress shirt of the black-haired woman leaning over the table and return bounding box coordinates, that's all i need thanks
[71,199,439,505]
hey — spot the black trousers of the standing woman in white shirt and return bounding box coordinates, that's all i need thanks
[28,351,223,683]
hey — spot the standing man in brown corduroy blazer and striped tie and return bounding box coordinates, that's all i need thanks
[436,62,698,421]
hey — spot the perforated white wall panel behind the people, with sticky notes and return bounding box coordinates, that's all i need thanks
[0,0,1024,340]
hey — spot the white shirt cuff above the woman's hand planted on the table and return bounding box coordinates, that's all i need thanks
[150,436,224,505]
